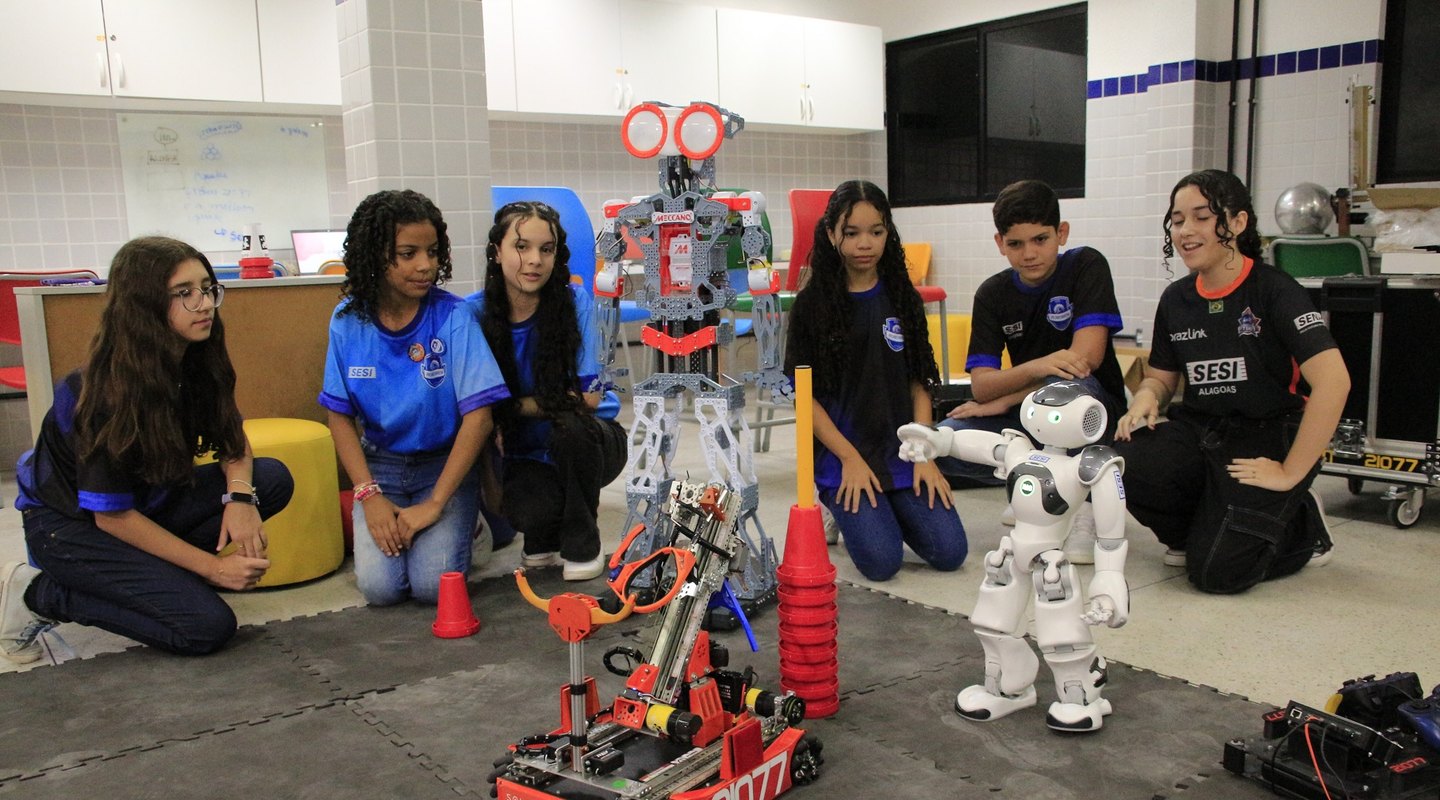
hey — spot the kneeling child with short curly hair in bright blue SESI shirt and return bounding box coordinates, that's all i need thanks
[320,190,510,606]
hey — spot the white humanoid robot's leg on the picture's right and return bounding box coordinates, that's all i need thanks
[1034,550,1110,731]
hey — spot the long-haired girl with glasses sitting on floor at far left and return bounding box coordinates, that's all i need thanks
[0,236,294,663]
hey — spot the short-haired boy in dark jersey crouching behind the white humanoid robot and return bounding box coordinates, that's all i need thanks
[940,180,1125,564]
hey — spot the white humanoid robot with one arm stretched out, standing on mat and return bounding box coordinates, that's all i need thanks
[899,381,1130,731]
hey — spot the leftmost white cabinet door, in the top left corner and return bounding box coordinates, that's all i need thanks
[0,0,109,96]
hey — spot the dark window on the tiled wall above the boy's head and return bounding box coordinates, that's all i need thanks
[886,4,1086,206]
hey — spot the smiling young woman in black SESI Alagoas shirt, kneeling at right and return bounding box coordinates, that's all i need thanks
[1115,170,1349,594]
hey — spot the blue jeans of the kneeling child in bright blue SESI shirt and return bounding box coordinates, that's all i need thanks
[351,443,480,606]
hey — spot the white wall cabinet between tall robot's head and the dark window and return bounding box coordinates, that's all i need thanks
[717,9,886,131]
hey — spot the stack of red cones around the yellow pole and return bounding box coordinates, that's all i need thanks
[775,505,840,719]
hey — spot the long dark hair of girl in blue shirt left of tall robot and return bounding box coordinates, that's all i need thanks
[480,200,588,430]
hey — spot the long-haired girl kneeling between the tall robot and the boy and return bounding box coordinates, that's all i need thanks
[785,181,968,581]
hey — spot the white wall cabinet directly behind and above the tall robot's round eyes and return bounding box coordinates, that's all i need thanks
[506,0,719,117]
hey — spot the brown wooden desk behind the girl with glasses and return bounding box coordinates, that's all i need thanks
[16,275,344,439]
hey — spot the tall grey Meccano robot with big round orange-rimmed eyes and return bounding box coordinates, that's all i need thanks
[595,102,791,607]
